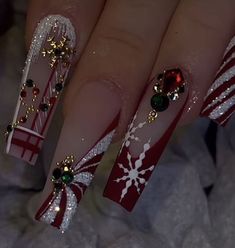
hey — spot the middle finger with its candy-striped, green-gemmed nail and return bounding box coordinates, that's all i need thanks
[36,0,180,230]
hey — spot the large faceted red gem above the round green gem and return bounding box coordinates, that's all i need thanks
[163,69,184,93]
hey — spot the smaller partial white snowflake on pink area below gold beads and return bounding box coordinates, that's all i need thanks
[120,114,146,153]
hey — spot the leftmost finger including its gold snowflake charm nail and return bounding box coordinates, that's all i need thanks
[6,0,103,164]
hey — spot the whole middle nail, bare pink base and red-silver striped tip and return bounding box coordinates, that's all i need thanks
[35,83,121,232]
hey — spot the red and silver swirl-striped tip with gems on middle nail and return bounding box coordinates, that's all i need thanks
[35,114,119,232]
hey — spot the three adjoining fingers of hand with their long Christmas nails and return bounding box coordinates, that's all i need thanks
[7,0,235,230]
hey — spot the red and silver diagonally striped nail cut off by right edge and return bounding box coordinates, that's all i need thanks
[201,37,235,126]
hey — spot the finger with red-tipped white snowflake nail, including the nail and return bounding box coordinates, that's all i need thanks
[104,0,234,211]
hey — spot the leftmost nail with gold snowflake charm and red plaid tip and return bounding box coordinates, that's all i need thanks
[6,15,76,164]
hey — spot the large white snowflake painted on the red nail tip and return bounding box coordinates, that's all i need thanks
[115,139,154,202]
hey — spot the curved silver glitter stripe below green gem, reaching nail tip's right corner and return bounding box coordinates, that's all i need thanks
[60,187,77,232]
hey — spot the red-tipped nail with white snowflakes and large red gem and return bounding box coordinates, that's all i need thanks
[104,69,188,211]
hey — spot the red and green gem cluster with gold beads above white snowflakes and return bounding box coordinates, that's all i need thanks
[148,68,185,123]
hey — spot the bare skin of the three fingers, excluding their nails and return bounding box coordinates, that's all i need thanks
[26,0,235,210]
